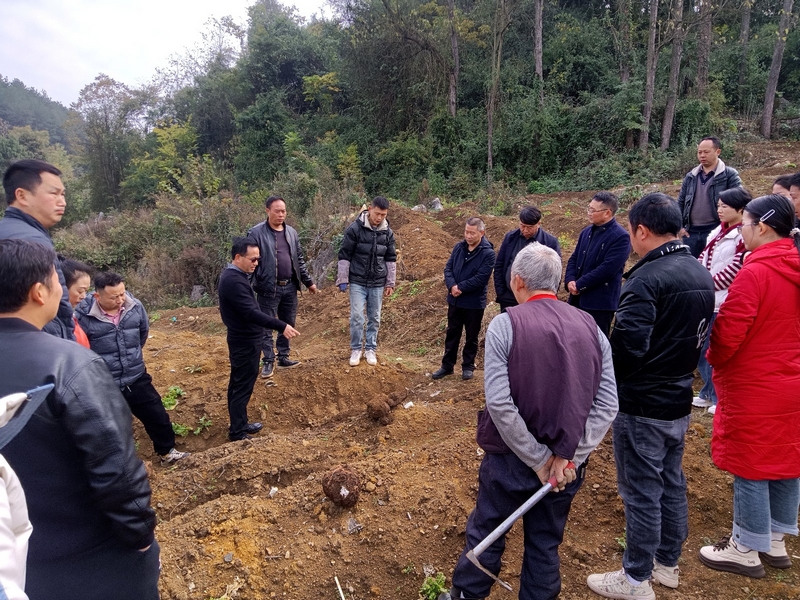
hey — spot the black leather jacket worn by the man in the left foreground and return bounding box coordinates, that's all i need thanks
[0,318,156,564]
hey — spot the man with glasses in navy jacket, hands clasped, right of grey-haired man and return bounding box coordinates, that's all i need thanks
[564,192,631,337]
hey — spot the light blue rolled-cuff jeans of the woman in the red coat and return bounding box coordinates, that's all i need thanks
[733,476,800,552]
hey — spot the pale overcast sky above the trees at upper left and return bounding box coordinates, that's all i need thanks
[0,0,331,106]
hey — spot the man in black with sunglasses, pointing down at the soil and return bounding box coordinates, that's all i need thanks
[218,238,299,442]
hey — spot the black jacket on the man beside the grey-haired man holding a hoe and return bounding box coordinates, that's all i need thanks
[611,240,714,421]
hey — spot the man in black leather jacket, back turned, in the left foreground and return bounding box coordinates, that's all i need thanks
[0,240,159,600]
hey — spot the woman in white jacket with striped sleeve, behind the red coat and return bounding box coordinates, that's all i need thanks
[692,187,753,415]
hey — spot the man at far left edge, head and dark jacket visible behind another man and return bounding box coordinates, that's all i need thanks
[0,160,75,340]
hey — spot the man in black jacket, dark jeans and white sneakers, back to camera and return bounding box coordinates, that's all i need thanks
[587,193,714,600]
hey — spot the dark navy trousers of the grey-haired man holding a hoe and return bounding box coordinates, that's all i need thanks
[453,453,586,600]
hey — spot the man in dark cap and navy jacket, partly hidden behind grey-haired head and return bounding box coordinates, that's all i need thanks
[494,206,561,312]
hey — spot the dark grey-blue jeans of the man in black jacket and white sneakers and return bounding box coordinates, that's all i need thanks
[614,413,691,581]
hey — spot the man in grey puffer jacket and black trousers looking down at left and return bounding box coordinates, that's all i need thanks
[75,271,189,465]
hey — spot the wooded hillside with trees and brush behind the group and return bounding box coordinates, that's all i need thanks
[0,0,800,306]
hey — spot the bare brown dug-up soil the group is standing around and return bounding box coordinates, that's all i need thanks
[141,144,800,600]
